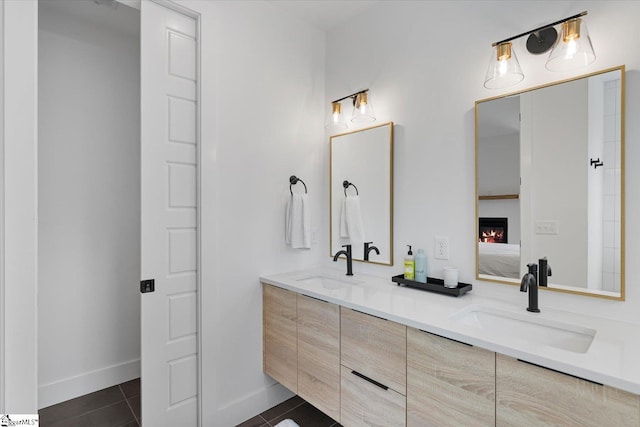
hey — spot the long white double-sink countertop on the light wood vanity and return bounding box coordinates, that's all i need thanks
[260,268,640,394]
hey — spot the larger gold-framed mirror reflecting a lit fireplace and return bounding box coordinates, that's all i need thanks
[475,65,625,300]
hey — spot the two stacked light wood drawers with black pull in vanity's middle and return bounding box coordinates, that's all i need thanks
[340,307,407,427]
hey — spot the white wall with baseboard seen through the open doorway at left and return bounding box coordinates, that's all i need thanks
[38,0,140,407]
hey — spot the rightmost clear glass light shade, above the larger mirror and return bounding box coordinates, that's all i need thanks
[545,18,596,71]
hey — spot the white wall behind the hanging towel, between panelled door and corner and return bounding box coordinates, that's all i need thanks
[181,0,329,426]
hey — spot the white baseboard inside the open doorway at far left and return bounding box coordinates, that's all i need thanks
[38,359,140,408]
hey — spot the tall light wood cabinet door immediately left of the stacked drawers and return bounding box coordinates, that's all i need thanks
[298,295,340,421]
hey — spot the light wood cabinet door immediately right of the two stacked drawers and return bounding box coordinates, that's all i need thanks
[407,328,495,427]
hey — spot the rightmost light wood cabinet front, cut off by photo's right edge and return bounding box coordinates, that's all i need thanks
[496,354,640,427]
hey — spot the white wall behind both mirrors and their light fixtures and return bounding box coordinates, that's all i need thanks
[325,1,640,323]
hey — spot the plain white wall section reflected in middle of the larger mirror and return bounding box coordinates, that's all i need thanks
[520,79,589,288]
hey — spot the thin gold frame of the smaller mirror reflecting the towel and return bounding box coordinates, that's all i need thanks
[329,122,393,265]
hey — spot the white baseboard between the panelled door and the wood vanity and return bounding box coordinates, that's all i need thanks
[214,383,294,426]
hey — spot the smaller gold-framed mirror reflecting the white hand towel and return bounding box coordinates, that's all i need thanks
[329,122,393,265]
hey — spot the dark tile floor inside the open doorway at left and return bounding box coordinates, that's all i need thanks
[39,378,140,427]
